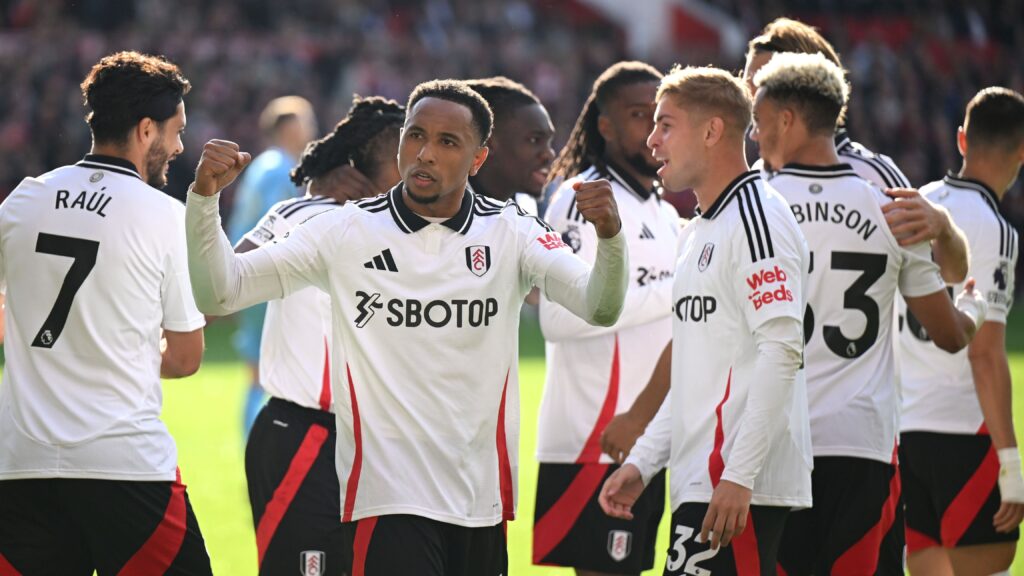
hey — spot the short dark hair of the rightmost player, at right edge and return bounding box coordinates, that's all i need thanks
[964,86,1024,154]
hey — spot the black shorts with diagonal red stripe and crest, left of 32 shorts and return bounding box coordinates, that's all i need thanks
[534,462,665,574]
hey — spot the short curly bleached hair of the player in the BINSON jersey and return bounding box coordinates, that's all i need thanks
[754,52,850,134]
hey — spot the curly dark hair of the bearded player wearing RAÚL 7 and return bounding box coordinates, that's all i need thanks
[81,51,191,143]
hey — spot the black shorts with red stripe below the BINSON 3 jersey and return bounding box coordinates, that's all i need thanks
[778,456,903,576]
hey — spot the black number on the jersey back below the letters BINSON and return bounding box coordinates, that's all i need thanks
[804,252,889,358]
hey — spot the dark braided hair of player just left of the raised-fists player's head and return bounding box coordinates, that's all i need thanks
[292,95,406,186]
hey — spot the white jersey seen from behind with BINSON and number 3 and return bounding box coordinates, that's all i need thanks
[771,164,945,463]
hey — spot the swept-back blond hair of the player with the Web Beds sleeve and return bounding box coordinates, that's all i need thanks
[655,65,752,137]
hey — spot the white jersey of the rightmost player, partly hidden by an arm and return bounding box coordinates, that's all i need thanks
[900,174,1018,435]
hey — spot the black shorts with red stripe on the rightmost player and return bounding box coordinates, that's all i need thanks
[899,431,1020,553]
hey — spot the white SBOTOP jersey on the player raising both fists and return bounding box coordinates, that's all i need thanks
[248,184,598,527]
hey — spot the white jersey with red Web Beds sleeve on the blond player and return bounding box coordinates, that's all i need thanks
[668,171,812,507]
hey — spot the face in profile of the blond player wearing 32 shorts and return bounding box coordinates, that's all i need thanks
[646,94,705,191]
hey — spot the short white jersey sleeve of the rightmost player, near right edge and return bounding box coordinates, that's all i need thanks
[968,219,1017,324]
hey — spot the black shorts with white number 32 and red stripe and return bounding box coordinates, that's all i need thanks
[665,502,790,576]
